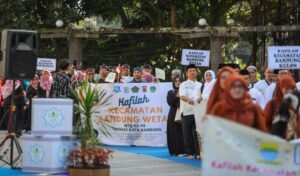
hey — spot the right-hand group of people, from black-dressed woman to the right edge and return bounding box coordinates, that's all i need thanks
[167,64,300,158]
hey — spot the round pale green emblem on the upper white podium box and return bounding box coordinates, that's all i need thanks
[44,108,64,128]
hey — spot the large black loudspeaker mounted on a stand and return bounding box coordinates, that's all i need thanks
[0,29,38,79]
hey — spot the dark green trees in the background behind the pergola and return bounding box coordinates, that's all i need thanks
[0,0,299,71]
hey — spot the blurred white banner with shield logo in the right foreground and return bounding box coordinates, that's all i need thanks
[203,116,300,176]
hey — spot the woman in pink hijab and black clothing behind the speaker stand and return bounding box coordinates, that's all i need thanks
[1,80,26,136]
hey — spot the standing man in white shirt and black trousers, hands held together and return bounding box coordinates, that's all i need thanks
[179,64,202,158]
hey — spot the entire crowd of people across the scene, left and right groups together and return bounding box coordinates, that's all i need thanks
[0,59,300,161]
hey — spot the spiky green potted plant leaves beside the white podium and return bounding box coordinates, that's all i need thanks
[71,81,111,148]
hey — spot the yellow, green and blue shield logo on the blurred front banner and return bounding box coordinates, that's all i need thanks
[257,142,282,165]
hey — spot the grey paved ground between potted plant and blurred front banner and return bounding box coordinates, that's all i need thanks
[0,132,201,176]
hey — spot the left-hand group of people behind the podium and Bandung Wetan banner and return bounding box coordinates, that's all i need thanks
[0,59,159,136]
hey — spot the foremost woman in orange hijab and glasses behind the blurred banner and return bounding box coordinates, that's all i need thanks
[211,74,267,131]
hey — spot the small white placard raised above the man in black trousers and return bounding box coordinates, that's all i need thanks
[181,49,210,67]
